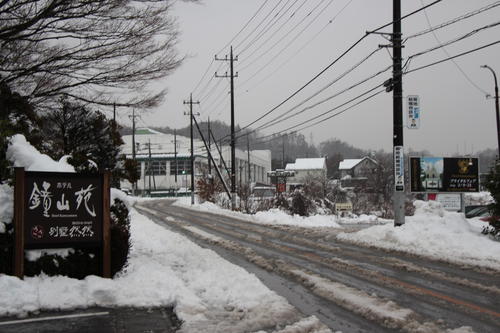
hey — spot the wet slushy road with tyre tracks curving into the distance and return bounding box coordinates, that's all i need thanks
[137,200,500,333]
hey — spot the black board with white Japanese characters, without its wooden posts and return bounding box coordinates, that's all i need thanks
[24,172,103,249]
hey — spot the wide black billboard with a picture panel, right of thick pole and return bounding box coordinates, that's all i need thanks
[410,157,479,193]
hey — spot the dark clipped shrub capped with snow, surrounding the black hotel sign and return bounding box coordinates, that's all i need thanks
[0,135,130,278]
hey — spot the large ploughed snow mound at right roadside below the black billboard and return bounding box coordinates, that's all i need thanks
[337,201,500,269]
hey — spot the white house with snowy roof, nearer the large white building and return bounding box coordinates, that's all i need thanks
[285,157,326,191]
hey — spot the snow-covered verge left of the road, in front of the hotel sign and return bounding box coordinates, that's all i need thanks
[0,210,304,332]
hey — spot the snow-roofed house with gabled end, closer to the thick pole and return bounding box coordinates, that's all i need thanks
[339,157,379,187]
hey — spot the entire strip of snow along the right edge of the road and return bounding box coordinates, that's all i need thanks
[175,197,500,270]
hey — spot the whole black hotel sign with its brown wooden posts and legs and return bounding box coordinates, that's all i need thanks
[14,168,111,278]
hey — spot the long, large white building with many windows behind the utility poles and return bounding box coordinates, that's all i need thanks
[120,128,271,193]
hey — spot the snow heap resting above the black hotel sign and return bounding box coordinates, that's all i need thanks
[7,134,75,172]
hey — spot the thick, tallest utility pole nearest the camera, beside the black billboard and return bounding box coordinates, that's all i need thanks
[392,0,405,226]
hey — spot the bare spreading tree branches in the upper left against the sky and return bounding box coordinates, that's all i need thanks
[0,0,195,108]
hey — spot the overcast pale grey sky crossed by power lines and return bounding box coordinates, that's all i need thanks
[131,0,500,156]
